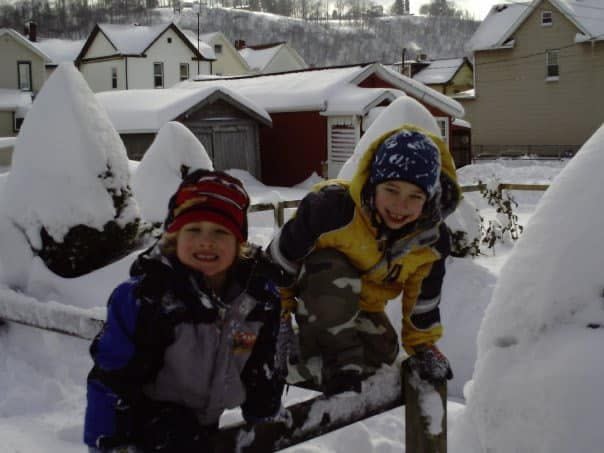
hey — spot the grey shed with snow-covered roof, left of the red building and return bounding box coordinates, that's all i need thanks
[96,86,272,178]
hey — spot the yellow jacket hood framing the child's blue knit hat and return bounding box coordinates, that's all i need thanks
[348,124,461,224]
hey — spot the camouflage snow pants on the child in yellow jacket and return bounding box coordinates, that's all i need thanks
[296,249,399,384]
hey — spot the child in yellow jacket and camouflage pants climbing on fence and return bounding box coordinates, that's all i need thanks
[269,125,461,394]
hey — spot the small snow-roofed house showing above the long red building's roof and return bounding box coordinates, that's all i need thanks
[235,40,308,74]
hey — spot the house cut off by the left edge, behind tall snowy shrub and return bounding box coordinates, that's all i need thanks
[0,28,50,137]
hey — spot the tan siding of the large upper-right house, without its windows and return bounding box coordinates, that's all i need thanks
[463,1,604,154]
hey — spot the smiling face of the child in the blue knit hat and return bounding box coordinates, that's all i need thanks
[375,181,427,230]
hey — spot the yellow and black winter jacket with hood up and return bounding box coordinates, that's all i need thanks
[271,125,461,354]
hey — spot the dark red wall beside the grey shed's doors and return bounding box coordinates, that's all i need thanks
[260,112,327,186]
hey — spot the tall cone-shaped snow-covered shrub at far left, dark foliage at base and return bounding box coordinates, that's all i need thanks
[3,63,139,277]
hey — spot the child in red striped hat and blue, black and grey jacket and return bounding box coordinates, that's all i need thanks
[84,170,283,452]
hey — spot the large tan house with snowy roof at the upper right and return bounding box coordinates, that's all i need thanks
[457,0,604,156]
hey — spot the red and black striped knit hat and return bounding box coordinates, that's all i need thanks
[164,170,250,242]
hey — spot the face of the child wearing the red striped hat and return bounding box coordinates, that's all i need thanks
[176,221,238,277]
